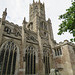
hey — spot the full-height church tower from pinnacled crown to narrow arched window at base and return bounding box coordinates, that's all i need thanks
[27,0,54,75]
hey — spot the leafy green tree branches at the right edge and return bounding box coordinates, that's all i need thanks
[58,1,75,42]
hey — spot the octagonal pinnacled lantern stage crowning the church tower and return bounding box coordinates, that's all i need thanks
[29,0,45,21]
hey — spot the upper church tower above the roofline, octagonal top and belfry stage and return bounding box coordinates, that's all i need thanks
[27,0,55,46]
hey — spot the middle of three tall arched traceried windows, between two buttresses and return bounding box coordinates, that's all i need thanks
[25,46,36,75]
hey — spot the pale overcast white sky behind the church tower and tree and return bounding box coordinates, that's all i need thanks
[0,0,72,42]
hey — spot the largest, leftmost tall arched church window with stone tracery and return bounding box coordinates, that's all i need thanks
[0,41,17,75]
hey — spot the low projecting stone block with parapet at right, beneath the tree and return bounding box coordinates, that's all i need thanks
[54,41,75,75]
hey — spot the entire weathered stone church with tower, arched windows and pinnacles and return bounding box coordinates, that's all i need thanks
[0,0,75,75]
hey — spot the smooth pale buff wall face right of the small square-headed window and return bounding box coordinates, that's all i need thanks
[62,45,73,75]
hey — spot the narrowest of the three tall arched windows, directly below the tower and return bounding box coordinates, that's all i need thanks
[43,50,50,75]
